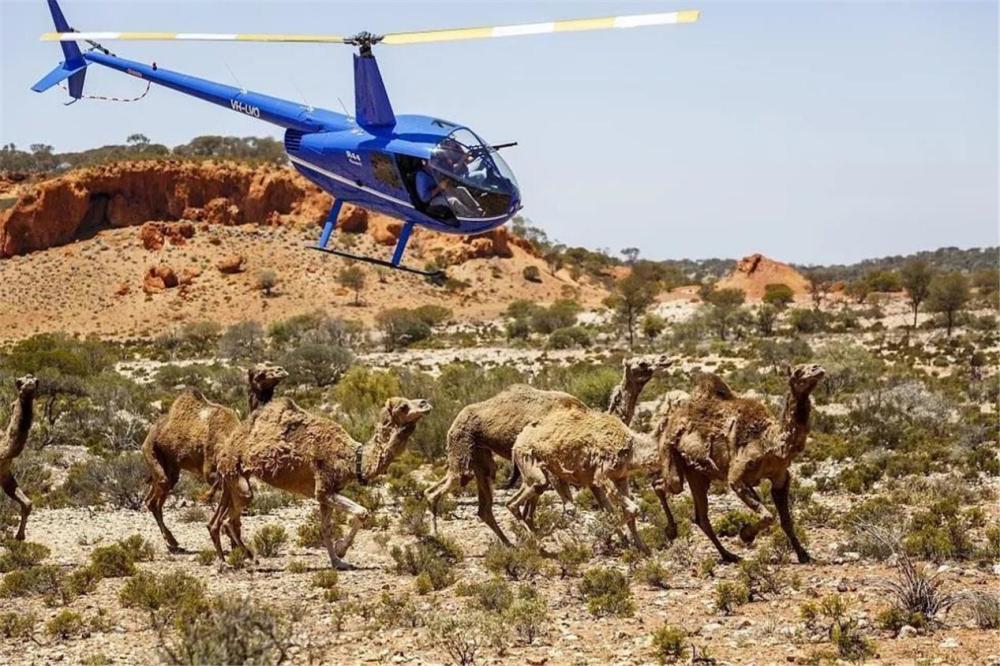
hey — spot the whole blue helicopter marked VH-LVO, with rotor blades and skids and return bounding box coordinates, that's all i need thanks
[32,0,698,278]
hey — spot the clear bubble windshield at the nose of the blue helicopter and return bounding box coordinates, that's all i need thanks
[417,128,519,219]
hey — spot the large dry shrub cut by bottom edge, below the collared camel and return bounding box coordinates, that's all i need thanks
[161,598,294,666]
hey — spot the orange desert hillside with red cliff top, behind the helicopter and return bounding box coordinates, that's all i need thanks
[0,160,606,338]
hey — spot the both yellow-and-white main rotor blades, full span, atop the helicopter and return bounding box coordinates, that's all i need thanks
[42,9,699,45]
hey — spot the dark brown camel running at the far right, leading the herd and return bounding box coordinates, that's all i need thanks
[659,364,826,563]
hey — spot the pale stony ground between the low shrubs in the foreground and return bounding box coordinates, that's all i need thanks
[0,472,1000,664]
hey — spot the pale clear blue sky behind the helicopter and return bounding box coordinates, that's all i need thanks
[0,0,1000,263]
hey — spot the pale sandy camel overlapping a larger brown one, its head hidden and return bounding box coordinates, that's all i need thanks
[507,410,656,553]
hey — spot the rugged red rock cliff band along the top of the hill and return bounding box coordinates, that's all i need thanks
[0,160,532,270]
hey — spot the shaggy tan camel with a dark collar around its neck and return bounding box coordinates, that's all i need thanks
[208,398,431,569]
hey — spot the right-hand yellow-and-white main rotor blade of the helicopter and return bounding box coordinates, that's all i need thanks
[380,10,699,44]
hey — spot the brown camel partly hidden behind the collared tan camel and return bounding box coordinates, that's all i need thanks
[142,363,288,552]
